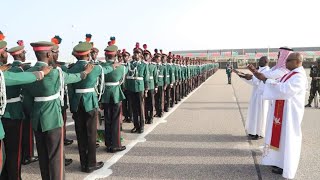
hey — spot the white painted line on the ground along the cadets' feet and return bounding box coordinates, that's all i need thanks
[84,75,213,180]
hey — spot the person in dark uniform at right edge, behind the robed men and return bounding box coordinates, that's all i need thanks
[305,58,320,107]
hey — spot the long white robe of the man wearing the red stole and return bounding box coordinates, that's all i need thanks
[262,67,308,179]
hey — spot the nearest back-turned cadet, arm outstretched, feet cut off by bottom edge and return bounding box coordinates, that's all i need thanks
[23,41,93,179]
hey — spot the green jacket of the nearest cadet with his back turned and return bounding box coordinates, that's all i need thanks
[23,61,81,132]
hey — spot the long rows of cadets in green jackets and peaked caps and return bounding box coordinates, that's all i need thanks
[0,32,216,180]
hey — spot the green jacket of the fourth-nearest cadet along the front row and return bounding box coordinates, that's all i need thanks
[126,61,150,92]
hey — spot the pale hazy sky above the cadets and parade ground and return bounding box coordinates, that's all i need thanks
[0,0,320,61]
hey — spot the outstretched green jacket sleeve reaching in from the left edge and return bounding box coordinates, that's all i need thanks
[0,71,37,140]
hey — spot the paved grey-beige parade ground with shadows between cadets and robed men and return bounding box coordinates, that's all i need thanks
[22,70,320,180]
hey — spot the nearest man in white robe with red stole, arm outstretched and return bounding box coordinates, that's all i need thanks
[255,53,308,179]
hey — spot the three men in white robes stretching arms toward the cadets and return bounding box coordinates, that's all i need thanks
[233,47,310,179]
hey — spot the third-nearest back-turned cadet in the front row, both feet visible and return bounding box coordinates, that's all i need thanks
[101,45,127,153]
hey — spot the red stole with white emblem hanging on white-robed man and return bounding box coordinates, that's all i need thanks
[270,72,298,149]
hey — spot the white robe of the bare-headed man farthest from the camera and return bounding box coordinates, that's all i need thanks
[244,66,270,137]
